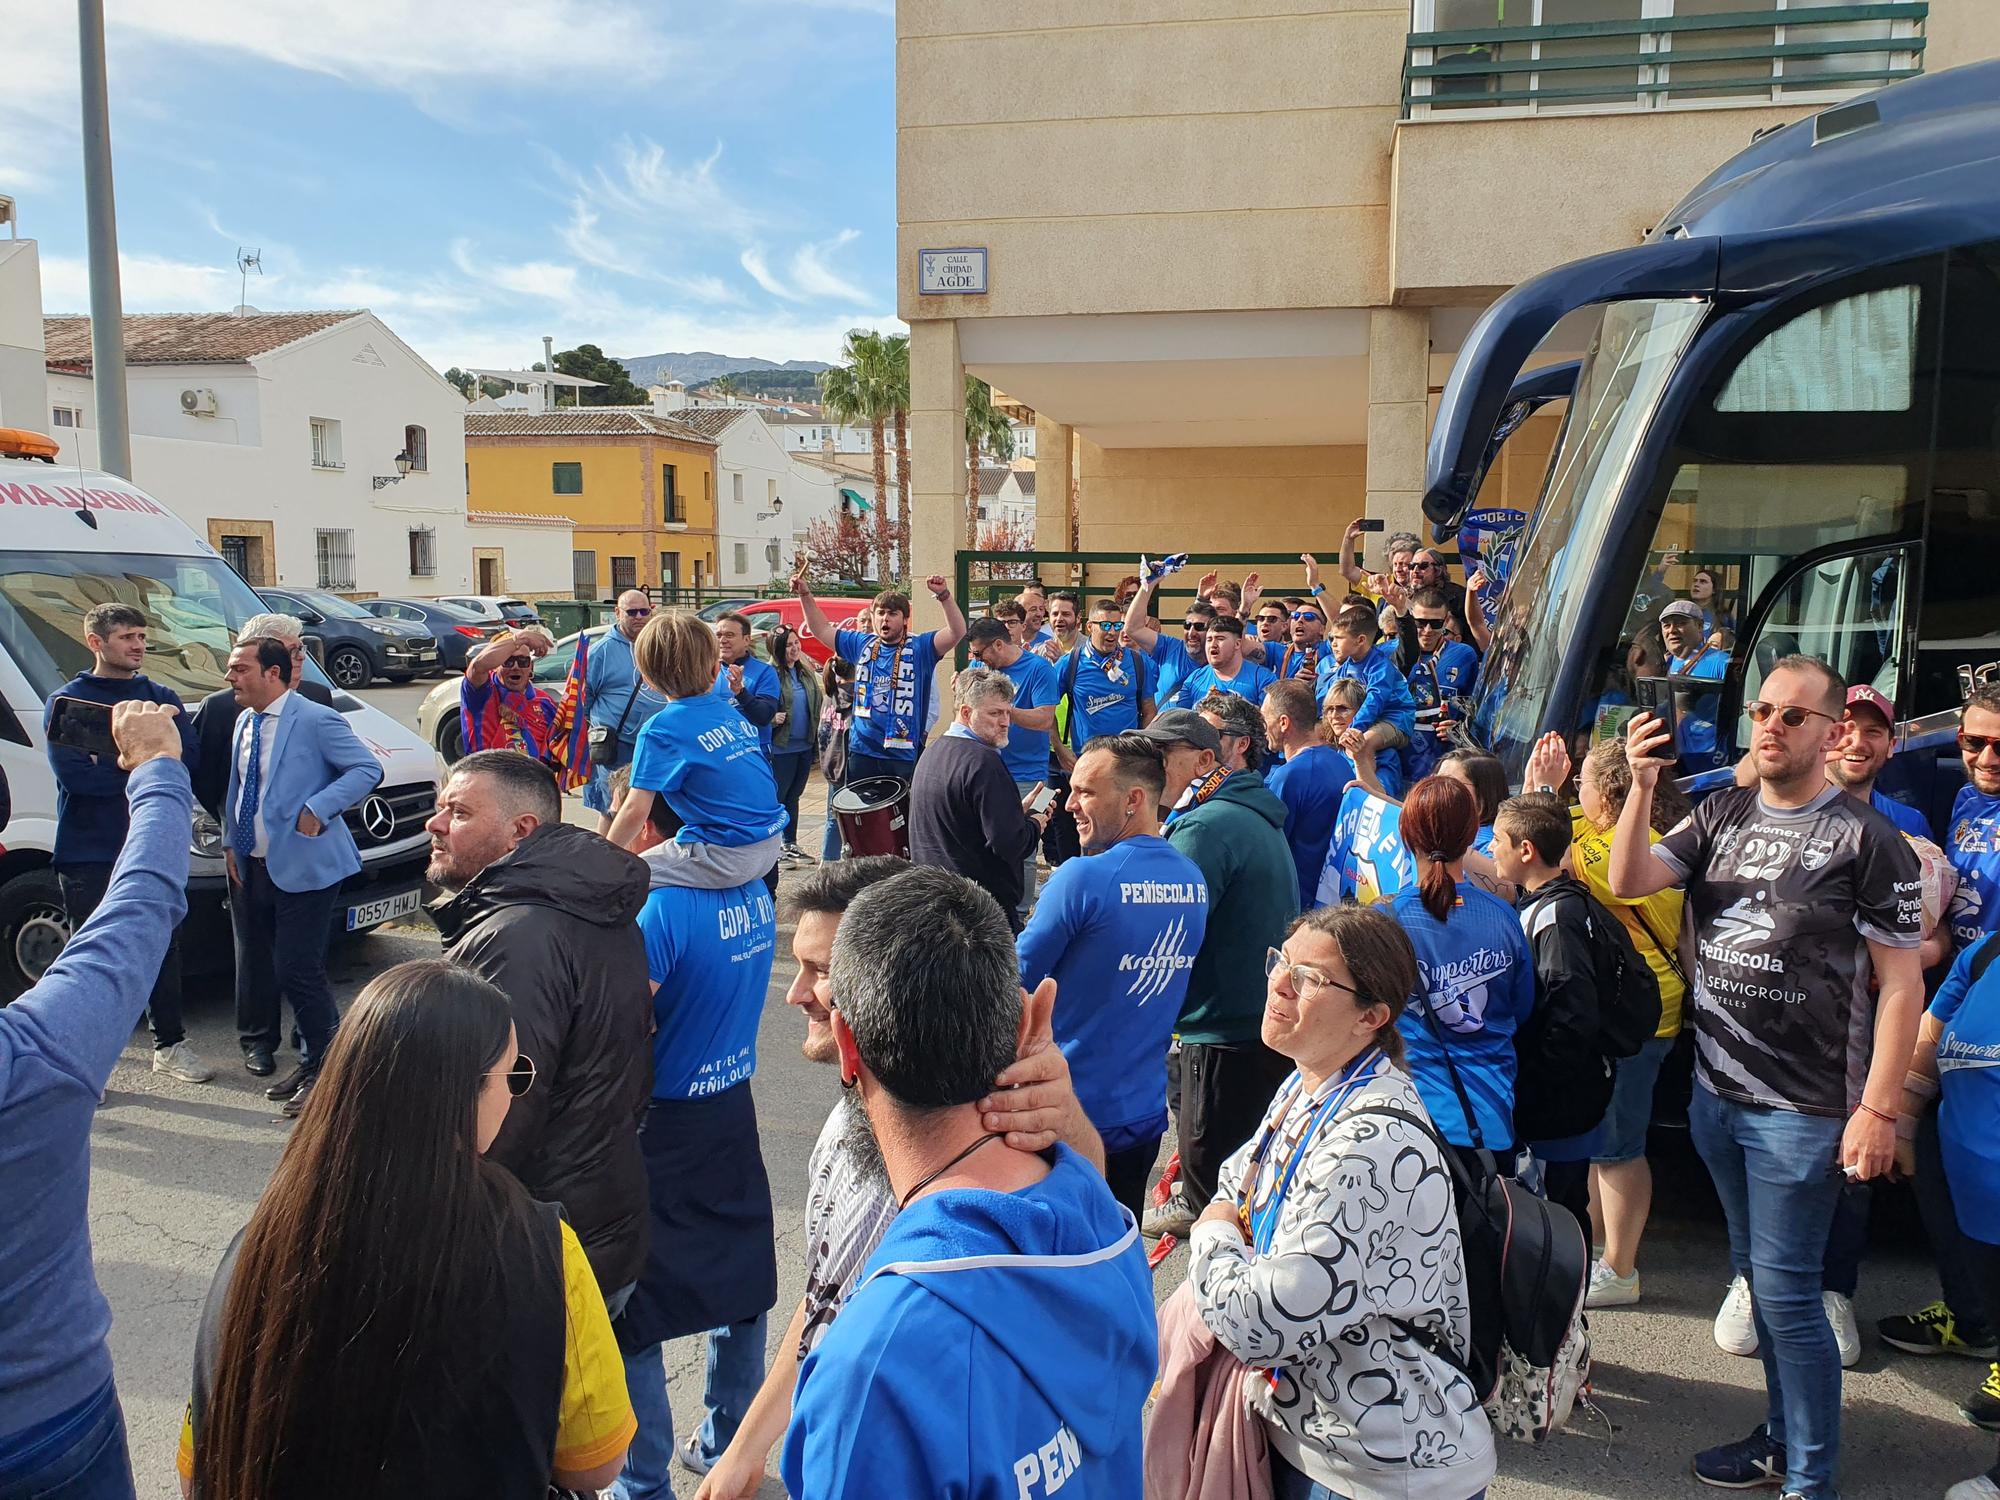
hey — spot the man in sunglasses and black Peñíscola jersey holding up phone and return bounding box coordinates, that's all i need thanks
[1608,656,1924,1498]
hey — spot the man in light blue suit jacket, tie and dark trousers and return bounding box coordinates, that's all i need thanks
[222,636,382,1118]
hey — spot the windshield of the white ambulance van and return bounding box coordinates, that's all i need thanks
[0,550,328,708]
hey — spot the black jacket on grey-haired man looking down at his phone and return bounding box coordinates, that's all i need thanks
[910,734,1042,932]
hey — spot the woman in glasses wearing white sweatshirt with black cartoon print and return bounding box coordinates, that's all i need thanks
[1188,906,1494,1500]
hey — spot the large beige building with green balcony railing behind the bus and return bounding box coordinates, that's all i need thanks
[896,0,2000,600]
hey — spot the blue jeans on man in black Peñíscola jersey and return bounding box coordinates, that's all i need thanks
[1688,1082,1844,1500]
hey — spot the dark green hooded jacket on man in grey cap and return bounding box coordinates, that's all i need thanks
[1166,770,1298,1042]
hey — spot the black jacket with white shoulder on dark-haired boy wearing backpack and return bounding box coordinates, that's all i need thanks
[1514,876,1616,1144]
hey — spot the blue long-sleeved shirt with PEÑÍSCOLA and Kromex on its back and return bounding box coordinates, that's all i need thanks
[1018,834,1208,1152]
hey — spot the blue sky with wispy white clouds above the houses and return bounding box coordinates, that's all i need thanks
[0,0,896,368]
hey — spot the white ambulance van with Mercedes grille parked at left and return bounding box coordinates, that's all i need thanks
[0,430,440,1002]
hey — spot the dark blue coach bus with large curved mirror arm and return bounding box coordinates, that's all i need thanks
[1424,64,2000,826]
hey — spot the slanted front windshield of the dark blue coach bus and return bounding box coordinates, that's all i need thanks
[1472,300,1708,782]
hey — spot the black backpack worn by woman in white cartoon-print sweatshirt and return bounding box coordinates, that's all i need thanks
[1374,1006,1590,1442]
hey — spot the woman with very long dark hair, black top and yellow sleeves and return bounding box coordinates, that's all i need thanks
[180,960,634,1500]
